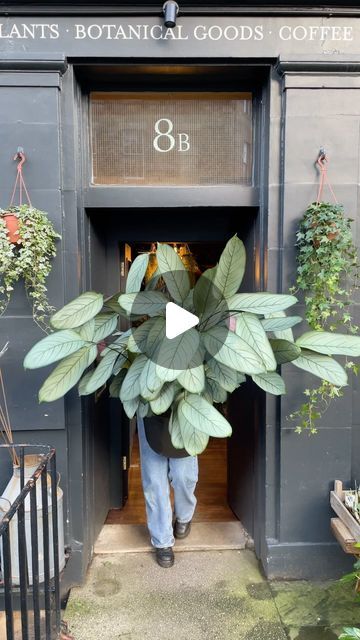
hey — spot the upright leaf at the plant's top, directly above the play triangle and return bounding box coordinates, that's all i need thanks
[156,243,190,302]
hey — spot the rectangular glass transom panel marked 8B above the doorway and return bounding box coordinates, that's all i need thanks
[90,92,253,186]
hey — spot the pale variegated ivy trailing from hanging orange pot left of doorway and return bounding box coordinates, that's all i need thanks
[0,205,61,331]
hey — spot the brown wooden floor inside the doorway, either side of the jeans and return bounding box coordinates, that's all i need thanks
[105,436,237,524]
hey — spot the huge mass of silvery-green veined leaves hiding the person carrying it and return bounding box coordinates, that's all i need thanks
[24,236,360,455]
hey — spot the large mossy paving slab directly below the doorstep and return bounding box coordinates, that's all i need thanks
[64,550,287,640]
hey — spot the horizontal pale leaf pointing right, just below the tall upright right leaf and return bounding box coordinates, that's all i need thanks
[228,293,297,315]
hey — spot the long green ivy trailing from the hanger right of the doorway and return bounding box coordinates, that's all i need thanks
[289,202,359,434]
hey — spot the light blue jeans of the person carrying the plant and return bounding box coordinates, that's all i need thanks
[137,417,198,547]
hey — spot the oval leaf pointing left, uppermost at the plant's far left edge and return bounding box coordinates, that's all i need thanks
[50,291,104,329]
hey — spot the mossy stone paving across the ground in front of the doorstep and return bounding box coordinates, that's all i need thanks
[63,550,360,640]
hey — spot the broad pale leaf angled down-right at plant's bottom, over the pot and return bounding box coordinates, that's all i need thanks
[178,393,231,438]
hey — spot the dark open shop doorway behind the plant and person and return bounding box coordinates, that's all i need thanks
[89,208,260,535]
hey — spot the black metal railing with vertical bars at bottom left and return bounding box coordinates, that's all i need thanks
[0,445,62,640]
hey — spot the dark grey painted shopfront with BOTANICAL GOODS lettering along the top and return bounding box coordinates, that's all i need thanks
[0,2,360,584]
